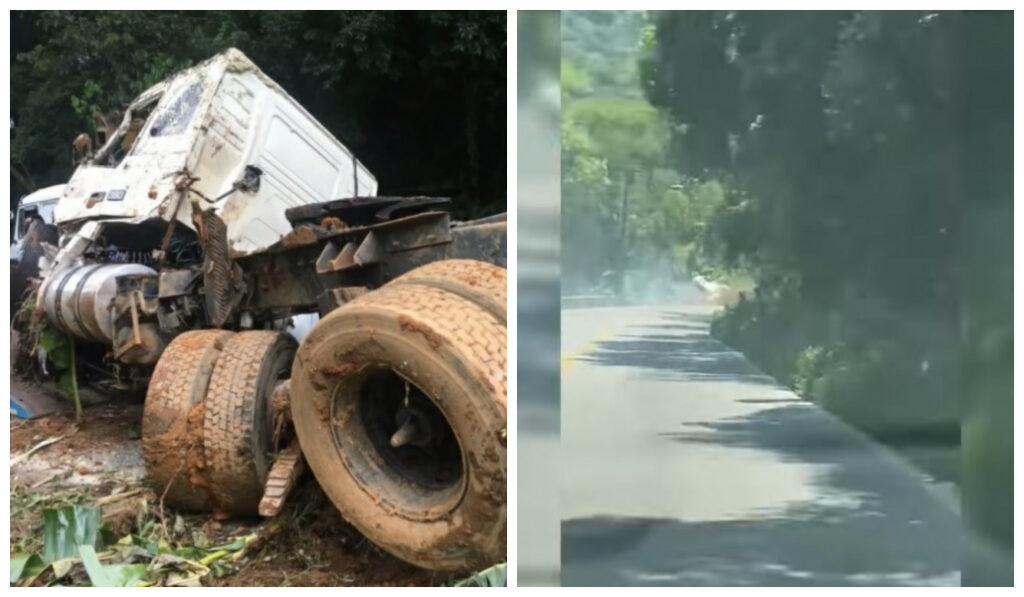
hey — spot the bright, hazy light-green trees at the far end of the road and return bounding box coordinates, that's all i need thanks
[561,11,746,300]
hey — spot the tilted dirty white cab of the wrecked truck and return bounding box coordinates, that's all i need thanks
[54,48,377,262]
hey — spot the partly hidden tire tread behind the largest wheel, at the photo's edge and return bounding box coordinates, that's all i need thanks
[388,259,508,324]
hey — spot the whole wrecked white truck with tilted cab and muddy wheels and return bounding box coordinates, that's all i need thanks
[18,49,507,570]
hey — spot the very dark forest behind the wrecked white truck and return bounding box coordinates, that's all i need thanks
[10,10,507,217]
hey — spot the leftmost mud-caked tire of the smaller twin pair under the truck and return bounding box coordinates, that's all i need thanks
[142,330,234,511]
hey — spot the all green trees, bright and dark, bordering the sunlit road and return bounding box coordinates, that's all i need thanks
[562,11,1013,584]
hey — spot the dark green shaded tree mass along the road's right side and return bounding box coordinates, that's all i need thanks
[639,11,1013,583]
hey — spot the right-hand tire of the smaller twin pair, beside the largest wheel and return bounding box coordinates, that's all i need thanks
[203,331,297,516]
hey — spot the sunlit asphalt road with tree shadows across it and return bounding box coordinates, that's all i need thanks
[559,305,963,586]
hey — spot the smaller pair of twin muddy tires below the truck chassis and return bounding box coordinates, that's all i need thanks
[142,330,297,517]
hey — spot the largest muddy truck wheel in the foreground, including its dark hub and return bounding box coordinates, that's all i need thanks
[291,281,507,570]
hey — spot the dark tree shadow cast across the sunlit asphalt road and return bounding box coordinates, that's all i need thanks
[562,313,964,586]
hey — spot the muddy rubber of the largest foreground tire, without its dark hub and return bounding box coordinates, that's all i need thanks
[292,284,508,571]
